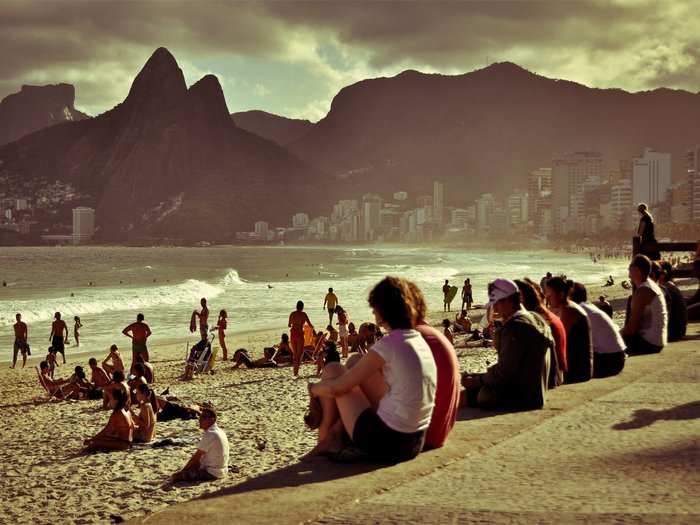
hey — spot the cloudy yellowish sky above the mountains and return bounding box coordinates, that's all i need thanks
[0,0,700,121]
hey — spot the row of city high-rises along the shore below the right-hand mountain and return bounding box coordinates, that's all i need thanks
[237,142,700,242]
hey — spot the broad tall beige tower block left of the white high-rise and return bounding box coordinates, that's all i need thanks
[551,151,603,233]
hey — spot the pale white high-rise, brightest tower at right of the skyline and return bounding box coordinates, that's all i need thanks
[632,148,671,206]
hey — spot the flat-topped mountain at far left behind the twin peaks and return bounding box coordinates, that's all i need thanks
[0,84,88,145]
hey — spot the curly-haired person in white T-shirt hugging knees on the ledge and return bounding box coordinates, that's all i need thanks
[307,277,437,462]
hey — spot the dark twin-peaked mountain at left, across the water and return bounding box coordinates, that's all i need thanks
[0,48,323,241]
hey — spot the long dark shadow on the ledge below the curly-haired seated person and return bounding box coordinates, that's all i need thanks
[193,458,391,499]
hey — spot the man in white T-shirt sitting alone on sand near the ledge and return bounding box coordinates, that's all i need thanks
[171,406,229,482]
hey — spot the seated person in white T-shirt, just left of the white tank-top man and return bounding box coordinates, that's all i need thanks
[569,283,627,378]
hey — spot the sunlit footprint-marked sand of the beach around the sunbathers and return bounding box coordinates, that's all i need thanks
[0,308,496,524]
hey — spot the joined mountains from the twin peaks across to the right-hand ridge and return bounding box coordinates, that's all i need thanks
[0,48,700,240]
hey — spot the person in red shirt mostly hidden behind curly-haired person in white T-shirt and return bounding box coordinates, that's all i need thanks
[408,281,461,450]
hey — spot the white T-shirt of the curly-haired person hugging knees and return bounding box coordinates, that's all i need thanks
[372,329,437,434]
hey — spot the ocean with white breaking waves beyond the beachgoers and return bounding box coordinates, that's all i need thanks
[0,245,627,361]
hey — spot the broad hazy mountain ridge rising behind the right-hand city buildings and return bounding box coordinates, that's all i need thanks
[287,62,700,205]
